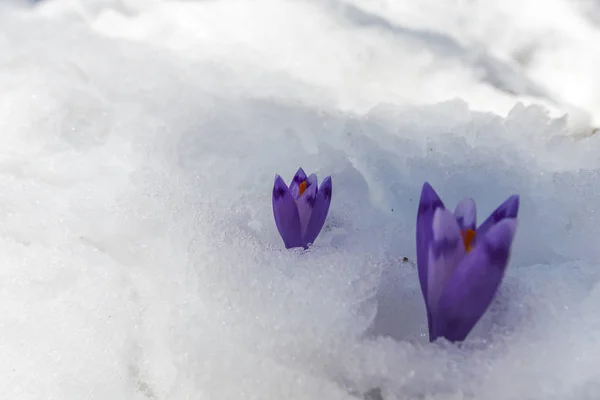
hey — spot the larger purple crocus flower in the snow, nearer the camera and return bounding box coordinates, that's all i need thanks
[417,182,519,342]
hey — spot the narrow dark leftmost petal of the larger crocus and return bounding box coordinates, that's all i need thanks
[417,182,444,312]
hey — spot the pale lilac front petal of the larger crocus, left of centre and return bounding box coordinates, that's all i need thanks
[427,208,466,338]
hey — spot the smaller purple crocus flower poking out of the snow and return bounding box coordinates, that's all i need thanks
[273,168,331,249]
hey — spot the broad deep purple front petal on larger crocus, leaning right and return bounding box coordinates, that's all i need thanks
[435,218,517,342]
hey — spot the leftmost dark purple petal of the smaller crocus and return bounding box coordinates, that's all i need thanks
[273,175,302,249]
